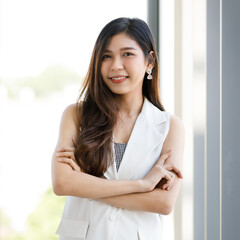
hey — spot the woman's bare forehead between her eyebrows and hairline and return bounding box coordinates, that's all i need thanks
[106,33,142,51]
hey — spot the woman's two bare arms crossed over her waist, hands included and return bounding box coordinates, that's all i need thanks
[52,105,184,214]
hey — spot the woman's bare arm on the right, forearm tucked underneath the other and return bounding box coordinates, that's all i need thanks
[97,117,184,215]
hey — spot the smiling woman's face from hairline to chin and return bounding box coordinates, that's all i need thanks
[101,33,148,94]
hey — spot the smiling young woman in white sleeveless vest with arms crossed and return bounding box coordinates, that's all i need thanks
[52,18,184,240]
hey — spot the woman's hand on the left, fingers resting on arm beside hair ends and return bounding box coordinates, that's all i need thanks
[56,147,81,172]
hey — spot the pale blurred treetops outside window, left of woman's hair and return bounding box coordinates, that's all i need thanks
[3,65,82,98]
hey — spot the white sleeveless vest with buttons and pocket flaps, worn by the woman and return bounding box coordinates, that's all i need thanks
[57,98,170,240]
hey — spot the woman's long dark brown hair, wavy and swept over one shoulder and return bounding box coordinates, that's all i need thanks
[75,18,164,176]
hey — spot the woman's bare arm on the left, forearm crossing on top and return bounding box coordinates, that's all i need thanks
[52,105,177,198]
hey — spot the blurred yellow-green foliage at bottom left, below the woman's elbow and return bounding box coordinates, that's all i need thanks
[1,187,65,240]
